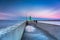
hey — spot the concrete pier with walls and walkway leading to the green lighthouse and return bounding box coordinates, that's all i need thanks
[0,21,60,40]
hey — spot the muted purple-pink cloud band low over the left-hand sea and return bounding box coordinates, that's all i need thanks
[0,12,22,20]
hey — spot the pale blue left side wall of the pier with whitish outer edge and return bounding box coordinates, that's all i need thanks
[0,23,25,40]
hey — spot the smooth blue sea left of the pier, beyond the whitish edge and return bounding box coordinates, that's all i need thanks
[0,20,23,29]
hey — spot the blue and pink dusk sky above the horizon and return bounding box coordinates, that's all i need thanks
[0,0,60,20]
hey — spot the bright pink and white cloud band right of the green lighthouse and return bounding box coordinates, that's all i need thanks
[21,9,60,18]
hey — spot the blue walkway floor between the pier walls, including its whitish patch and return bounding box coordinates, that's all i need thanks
[22,25,56,40]
